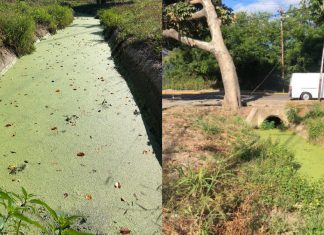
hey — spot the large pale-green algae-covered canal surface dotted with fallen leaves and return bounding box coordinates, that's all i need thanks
[0,17,162,234]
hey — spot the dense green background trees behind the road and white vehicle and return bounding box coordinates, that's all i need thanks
[164,0,324,90]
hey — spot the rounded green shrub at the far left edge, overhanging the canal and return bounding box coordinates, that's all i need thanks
[0,14,36,56]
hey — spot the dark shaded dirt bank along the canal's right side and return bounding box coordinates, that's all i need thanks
[104,29,162,158]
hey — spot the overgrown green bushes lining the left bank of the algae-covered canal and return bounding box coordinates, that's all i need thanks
[0,1,73,56]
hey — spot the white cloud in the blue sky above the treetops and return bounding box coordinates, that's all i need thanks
[233,0,300,13]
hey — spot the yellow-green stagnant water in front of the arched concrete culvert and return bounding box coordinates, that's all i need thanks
[257,129,324,180]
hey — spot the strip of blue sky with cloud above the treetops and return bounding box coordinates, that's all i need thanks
[223,0,300,13]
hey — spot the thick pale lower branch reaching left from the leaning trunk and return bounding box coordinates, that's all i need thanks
[162,29,212,51]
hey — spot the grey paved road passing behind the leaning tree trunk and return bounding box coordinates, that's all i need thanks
[162,91,289,108]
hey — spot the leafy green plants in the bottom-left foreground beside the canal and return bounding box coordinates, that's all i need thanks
[0,188,89,235]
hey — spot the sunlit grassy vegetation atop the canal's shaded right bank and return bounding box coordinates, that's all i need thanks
[98,0,162,58]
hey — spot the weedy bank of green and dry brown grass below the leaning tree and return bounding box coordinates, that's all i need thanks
[163,109,324,234]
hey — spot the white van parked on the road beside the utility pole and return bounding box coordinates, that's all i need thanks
[289,73,324,100]
